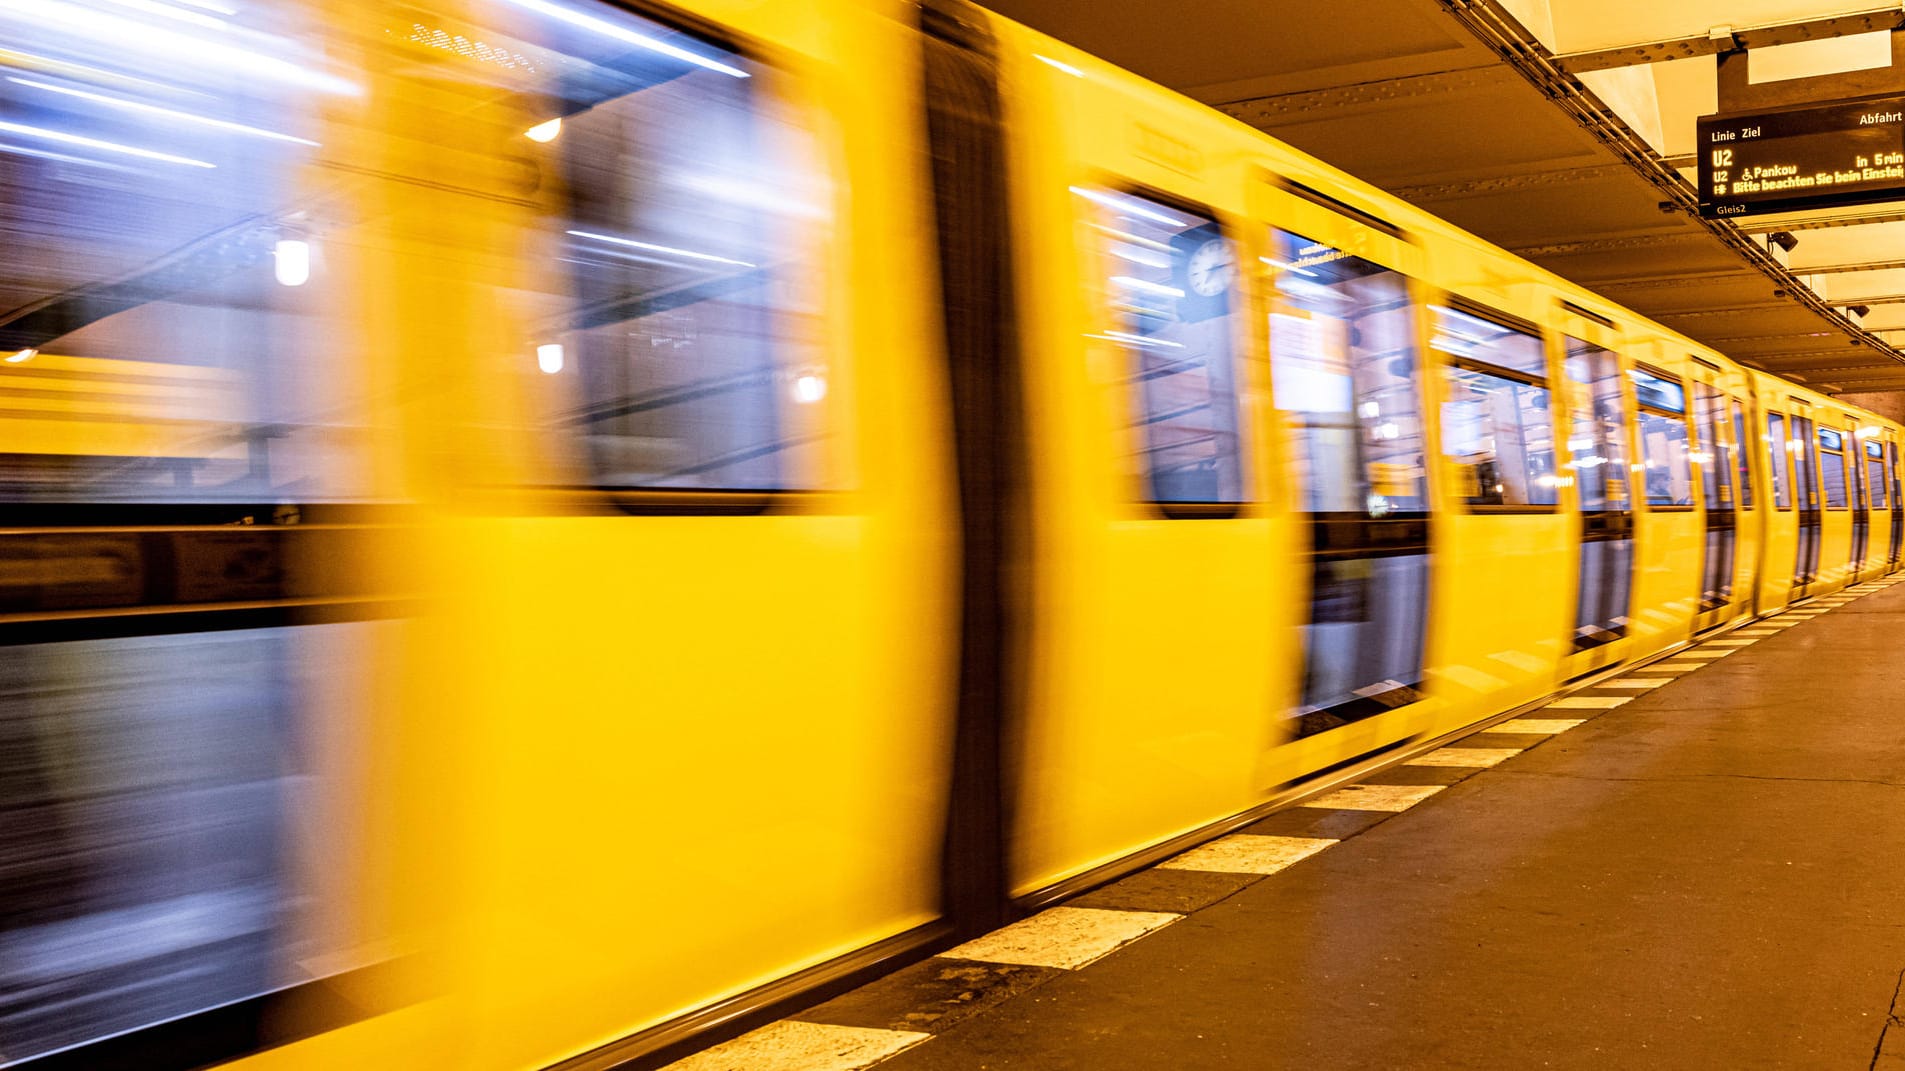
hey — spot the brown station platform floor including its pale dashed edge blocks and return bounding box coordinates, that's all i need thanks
[672,577,1905,1071]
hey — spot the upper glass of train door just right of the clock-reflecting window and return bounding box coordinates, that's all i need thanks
[1265,231,1429,516]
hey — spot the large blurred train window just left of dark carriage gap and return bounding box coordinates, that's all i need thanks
[537,16,827,492]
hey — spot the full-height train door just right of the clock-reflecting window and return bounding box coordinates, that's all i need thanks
[1263,231,1429,736]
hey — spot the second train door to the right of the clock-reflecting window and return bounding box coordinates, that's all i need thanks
[1562,309,1634,678]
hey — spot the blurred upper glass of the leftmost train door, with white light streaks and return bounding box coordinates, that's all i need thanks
[0,4,368,499]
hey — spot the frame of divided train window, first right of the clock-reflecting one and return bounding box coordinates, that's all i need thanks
[1421,292,1566,516]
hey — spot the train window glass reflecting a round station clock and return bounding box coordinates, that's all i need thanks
[1074,187,1244,503]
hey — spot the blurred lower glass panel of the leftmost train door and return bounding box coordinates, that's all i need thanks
[0,623,368,1060]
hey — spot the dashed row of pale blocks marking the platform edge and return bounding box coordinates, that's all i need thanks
[665,574,1905,1071]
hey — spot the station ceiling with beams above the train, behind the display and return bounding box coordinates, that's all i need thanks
[989,0,1905,394]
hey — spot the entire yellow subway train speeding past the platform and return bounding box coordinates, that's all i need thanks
[0,0,1905,1071]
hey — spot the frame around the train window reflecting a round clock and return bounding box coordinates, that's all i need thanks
[1069,173,1261,520]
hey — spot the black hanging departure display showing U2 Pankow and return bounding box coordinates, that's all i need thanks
[1697,97,1905,217]
